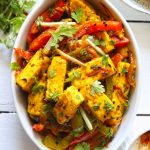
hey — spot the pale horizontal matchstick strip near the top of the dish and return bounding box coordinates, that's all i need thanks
[40,22,76,27]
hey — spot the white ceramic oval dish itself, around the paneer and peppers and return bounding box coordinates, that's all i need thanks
[12,0,141,150]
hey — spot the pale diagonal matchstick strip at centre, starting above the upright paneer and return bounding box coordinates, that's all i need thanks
[56,49,86,67]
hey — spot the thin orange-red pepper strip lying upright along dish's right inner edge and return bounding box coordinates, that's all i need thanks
[127,52,136,87]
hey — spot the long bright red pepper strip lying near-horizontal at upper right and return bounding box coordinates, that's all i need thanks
[76,21,122,38]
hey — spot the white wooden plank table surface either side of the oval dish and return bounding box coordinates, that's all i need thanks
[0,0,150,150]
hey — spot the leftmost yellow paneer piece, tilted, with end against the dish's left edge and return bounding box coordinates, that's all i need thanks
[16,50,50,92]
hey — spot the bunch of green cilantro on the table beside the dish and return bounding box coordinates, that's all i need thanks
[0,0,35,48]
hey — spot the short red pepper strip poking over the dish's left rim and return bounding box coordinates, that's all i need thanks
[14,48,34,60]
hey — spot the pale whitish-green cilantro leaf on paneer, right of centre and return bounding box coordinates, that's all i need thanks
[91,80,105,96]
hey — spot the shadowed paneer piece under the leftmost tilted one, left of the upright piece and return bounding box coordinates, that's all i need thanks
[28,73,47,117]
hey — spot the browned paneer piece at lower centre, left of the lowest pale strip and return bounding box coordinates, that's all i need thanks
[54,86,84,124]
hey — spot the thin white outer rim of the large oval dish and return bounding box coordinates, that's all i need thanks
[11,0,141,150]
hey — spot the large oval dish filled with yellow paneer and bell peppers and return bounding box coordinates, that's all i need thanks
[11,0,141,150]
